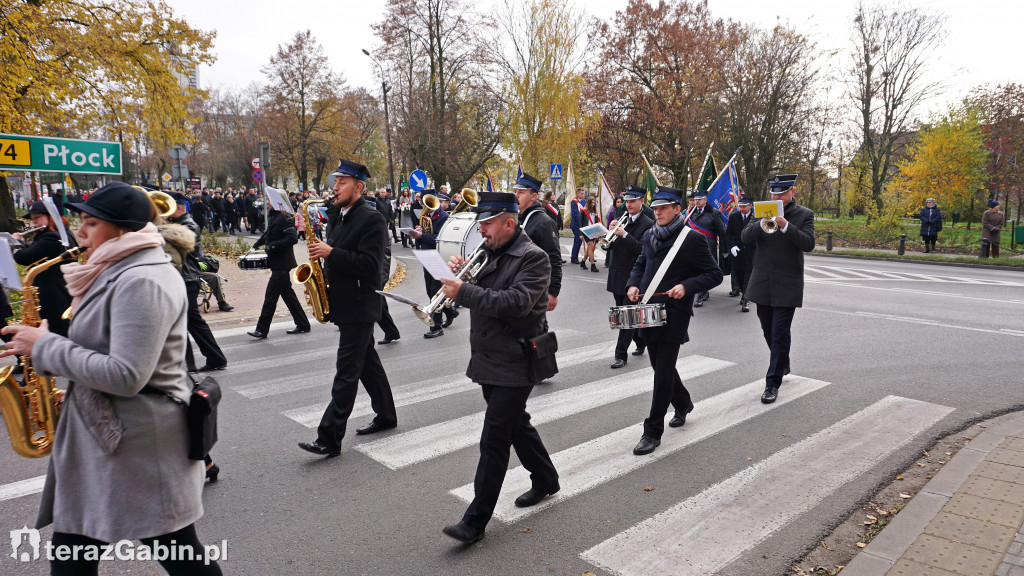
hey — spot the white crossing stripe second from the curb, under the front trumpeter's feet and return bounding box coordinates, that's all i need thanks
[452,375,828,524]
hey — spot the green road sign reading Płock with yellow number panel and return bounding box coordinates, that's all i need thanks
[0,134,121,174]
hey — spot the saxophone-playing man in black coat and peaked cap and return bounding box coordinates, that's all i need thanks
[299,160,398,457]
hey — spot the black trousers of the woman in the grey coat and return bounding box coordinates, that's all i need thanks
[50,524,222,576]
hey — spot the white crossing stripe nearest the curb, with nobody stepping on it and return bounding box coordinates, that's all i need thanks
[580,387,953,576]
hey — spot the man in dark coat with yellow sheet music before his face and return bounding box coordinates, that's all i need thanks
[741,174,814,404]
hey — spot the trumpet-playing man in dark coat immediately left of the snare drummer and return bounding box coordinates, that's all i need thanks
[607,186,654,368]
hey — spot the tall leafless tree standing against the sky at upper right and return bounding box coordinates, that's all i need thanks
[849,1,945,210]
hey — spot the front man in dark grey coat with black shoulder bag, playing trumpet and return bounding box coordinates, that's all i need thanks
[442,192,559,544]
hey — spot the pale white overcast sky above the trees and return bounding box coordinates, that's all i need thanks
[167,0,1024,118]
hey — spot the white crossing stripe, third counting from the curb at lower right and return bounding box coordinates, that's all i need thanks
[355,356,733,469]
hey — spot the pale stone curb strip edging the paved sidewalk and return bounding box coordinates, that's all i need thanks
[843,412,1024,576]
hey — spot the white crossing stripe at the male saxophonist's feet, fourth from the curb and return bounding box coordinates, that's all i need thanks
[280,342,615,428]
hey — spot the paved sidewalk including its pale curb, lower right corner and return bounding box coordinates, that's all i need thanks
[843,412,1024,576]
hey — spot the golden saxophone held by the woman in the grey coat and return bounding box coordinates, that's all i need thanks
[0,248,80,458]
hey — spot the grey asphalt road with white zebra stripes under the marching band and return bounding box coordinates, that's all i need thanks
[0,244,1024,576]
